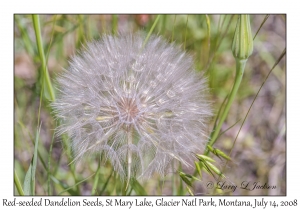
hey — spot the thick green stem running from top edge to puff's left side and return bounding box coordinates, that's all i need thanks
[32,15,55,101]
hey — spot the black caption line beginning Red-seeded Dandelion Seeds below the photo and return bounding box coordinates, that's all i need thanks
[2,197,298,209]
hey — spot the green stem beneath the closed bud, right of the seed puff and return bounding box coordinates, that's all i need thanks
[205,59,247,155]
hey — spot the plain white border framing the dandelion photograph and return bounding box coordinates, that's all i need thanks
[0,0,300,209]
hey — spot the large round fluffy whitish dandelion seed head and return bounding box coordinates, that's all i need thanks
[52,33,212,178]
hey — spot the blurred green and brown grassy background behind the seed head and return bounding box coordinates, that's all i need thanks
[14,14,286,195]
